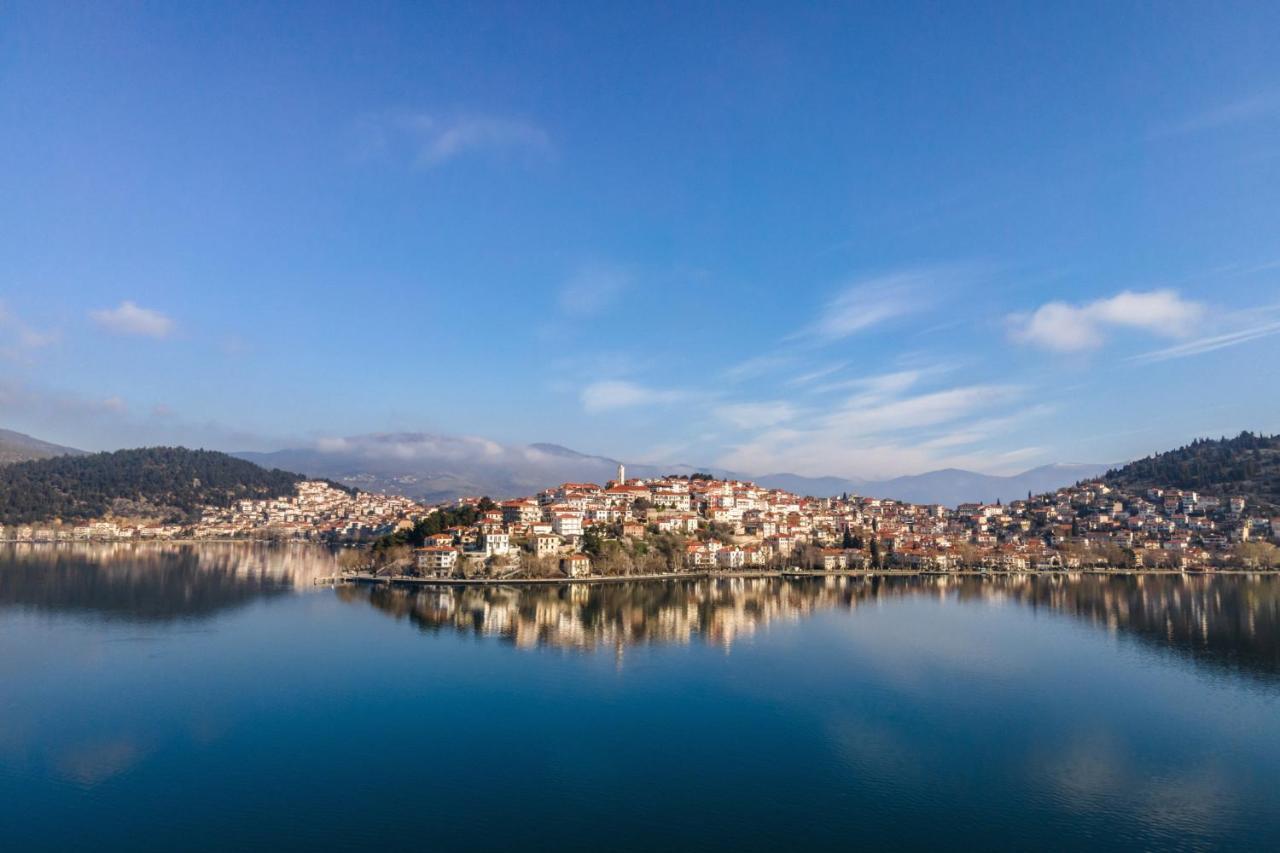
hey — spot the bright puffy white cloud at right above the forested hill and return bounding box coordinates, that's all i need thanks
[1009,291,1204,352]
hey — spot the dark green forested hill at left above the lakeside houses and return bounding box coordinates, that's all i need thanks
[0,447,305,524]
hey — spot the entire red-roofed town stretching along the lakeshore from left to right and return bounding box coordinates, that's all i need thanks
[0,466,1280,568]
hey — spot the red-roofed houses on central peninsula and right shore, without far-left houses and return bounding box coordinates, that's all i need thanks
[404,469,1280,578]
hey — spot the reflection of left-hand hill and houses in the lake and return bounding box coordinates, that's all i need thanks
[0,542,335,621]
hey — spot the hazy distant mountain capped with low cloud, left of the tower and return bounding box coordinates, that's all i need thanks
[236,433,726,502]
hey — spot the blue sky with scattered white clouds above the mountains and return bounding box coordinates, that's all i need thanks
[0,0,1280,478]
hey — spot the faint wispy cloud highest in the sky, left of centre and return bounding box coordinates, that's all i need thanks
[358,113,552,169]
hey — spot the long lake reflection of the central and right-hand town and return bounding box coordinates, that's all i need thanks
[337,575,1280,676]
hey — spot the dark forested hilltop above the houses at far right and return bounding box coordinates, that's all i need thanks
[1105,433,1280,514]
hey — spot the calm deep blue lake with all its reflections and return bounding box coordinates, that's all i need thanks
[0,546,1280,850]
